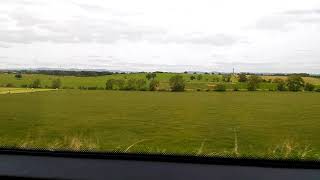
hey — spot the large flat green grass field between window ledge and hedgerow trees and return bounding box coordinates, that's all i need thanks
[0,90,320,159]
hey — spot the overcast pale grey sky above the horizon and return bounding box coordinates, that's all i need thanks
[0,0,320,73]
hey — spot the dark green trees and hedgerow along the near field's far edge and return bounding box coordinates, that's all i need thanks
[1,73,320,91]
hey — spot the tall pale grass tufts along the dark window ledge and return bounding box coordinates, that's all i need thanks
[0,129,320,161]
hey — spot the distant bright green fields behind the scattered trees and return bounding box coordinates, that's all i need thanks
[0,73,320,90]
